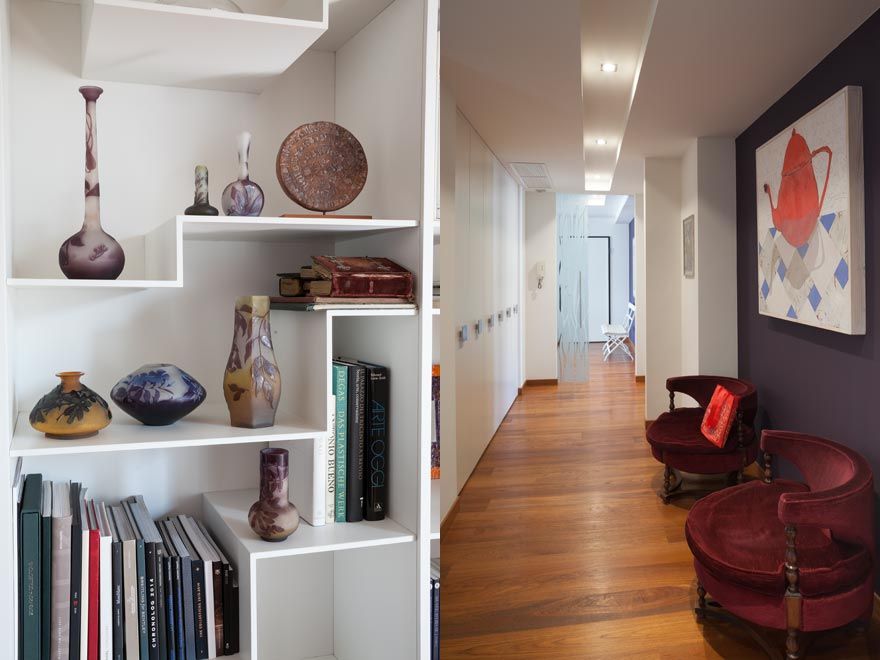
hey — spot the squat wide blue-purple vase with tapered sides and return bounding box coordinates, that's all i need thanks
[110,364,206,426]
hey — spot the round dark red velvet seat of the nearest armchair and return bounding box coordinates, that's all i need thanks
[685,479,871,596]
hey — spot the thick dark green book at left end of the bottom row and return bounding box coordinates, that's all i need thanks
[19,474,43,660]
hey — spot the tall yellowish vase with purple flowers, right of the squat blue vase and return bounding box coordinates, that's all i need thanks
[223,296,281,429]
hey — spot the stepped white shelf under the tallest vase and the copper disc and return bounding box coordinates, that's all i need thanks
[6,215,418,288]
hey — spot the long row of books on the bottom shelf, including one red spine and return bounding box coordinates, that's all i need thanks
[17,474,239,660]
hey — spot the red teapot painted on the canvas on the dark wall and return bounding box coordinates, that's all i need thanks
[764,128,833,248]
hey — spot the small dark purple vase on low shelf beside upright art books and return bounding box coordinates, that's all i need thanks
[248,447,299,541]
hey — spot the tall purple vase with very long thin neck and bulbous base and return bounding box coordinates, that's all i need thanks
[58,87,125,280]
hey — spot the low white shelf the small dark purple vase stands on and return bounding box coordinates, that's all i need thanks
[204,489,416,559]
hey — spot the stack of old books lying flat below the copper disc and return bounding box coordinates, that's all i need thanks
[272,256,415,309]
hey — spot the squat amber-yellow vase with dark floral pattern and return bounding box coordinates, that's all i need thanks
[30,371,113,440]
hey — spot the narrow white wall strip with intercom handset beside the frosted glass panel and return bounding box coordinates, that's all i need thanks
[523,192,557,380]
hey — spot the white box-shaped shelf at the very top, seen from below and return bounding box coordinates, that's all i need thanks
[82,0,329,92]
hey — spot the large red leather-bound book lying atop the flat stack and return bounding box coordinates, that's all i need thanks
[312,256,413,299]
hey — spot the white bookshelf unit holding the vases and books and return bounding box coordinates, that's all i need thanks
[0,0,439,660]
